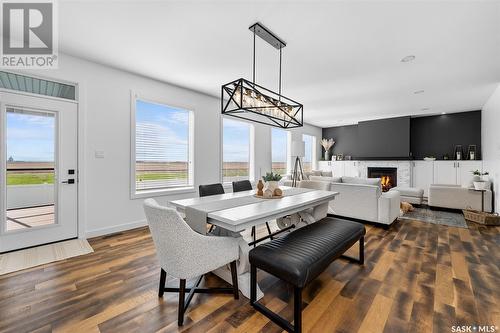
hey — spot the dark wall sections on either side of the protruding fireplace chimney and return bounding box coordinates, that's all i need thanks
[323,111,481,159]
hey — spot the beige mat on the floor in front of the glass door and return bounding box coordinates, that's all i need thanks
[0,239,94,275]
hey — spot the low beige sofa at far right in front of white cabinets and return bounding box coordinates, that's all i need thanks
[428,184,492,212]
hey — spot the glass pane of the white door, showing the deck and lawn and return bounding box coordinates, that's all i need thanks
[5,108,56,231]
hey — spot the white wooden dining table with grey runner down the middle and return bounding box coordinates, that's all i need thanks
[169,186,338,299]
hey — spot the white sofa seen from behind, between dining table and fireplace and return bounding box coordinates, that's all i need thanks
[330,177,400,225]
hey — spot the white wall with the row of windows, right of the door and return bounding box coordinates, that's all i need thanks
[22,54,321,237]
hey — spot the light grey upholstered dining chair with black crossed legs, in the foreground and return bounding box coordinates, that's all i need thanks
[144,199,239,326]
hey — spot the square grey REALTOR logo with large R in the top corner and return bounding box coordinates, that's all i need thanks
[0,0,58,69]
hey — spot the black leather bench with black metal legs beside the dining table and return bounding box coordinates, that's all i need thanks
[249,217,366,332]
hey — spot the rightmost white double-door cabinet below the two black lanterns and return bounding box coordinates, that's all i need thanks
[434,161,483,187]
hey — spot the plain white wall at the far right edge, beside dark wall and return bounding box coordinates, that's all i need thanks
[481,85,500,213]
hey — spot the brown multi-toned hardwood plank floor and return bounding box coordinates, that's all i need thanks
[0,221,500,333]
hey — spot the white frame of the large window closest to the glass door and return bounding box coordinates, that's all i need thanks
[130,91,196,199]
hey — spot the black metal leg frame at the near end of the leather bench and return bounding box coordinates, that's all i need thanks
[250,265,302,333]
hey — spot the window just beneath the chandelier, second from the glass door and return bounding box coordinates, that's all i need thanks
[222,118,252,183]
